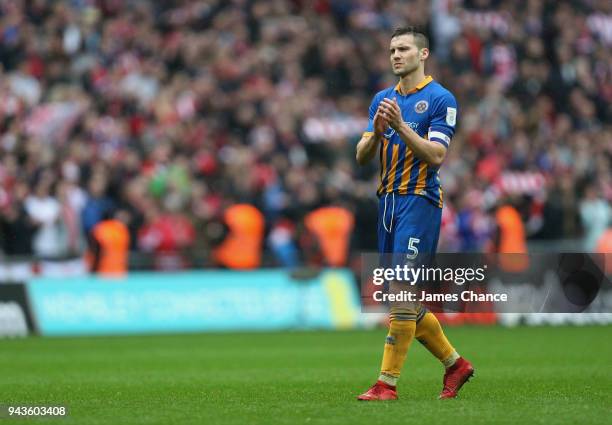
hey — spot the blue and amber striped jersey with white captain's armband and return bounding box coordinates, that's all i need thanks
[364,76,457,208]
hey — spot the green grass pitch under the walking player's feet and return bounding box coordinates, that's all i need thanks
[0,326,612,425]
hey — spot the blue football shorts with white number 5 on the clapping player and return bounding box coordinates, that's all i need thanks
[378,193,442,258]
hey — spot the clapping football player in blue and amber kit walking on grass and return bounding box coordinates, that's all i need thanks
[356,27,474,400]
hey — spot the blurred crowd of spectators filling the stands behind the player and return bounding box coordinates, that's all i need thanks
[0,0,612,264]
